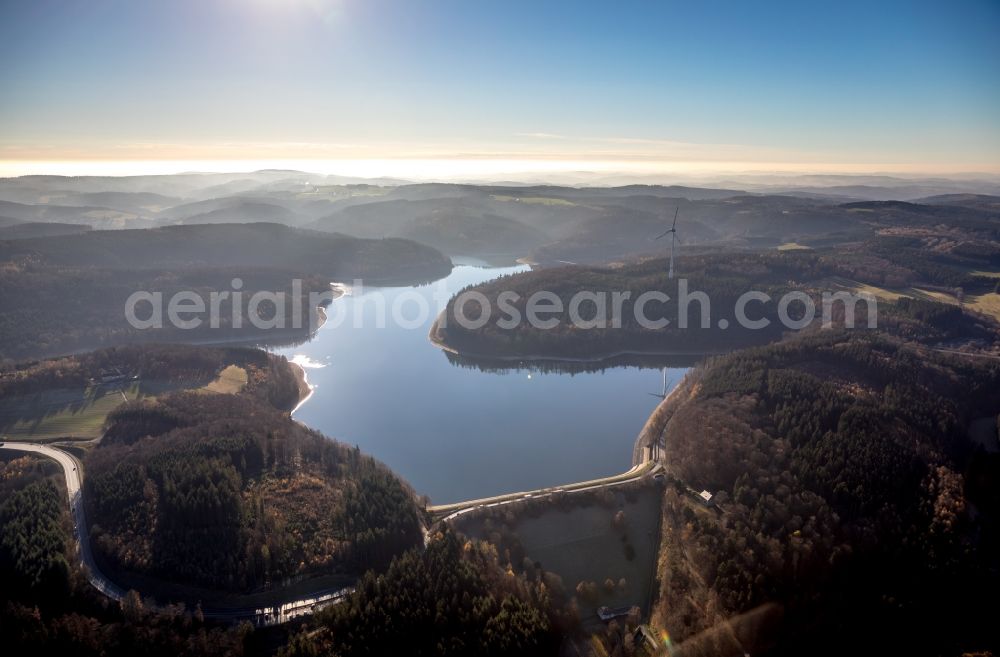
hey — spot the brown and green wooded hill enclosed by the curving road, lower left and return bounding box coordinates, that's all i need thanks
[85,393,422,591]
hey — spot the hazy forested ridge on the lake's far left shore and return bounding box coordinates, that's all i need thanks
[0,224,451,361]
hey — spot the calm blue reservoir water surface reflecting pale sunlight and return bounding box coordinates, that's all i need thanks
[275,265,686,504]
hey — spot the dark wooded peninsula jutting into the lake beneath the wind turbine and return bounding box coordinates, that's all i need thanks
[433,247,1000,359]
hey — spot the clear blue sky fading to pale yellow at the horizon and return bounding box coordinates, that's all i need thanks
[0,0,1000,178]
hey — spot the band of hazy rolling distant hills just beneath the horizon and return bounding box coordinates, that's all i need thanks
[0,170,1000,264]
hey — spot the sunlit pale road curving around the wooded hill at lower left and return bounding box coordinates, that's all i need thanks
[0,442,354,625]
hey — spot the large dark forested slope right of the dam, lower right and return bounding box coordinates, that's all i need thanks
[658,333,1000,654]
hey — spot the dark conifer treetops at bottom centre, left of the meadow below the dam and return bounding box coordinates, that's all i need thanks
[282,530,561,657]
